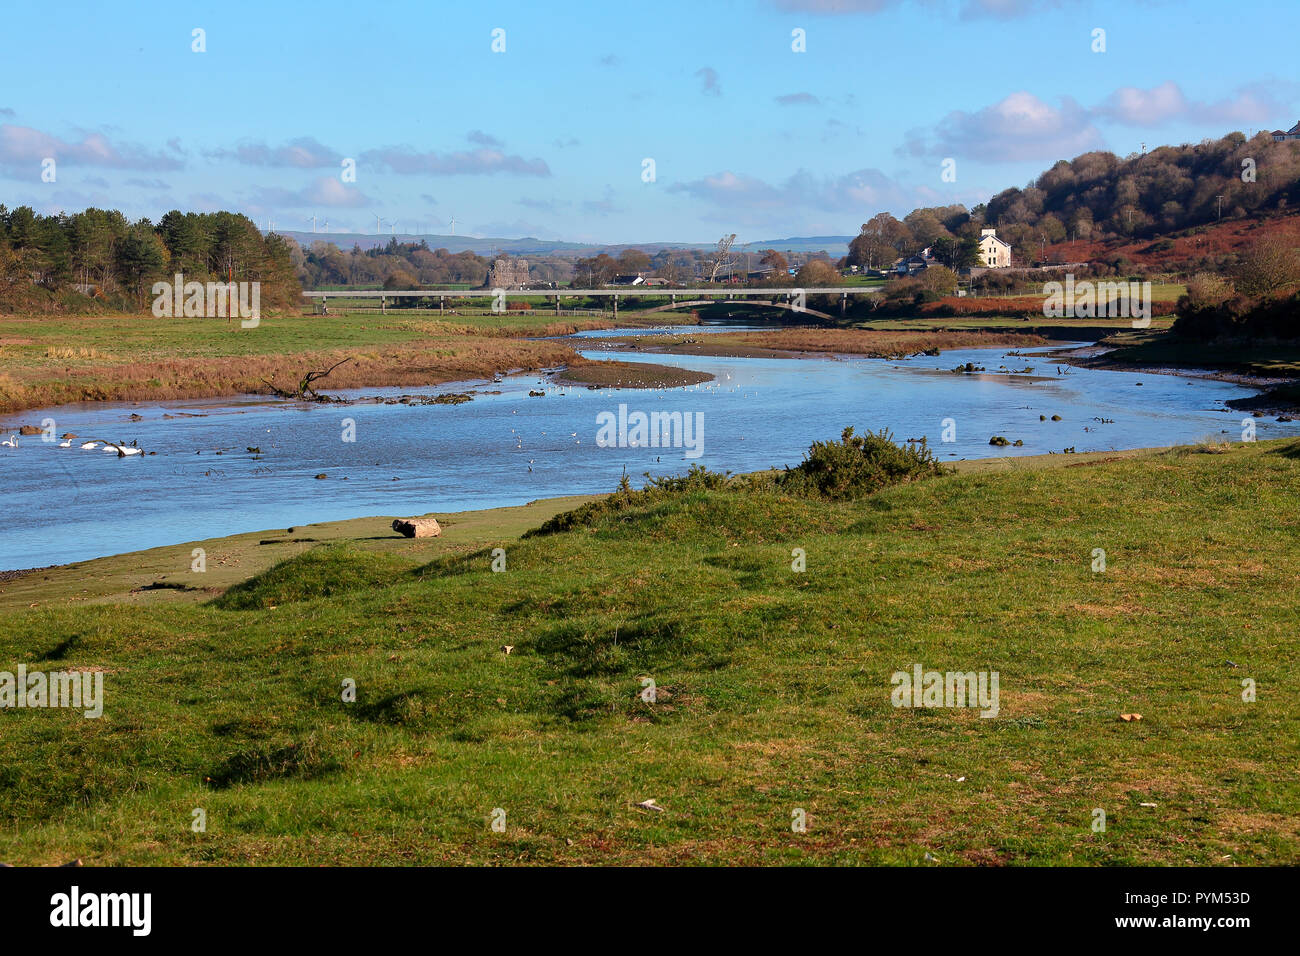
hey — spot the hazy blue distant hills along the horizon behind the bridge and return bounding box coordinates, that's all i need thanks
[280,230,853,259]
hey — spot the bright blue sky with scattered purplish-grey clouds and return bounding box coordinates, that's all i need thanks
[0,0,1300,243]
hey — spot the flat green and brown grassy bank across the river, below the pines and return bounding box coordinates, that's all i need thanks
[0,313,634,412]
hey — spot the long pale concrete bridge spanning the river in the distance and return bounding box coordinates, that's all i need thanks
[303,286,879,319]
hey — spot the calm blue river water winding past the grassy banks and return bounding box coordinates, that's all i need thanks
[0,338,1279,568]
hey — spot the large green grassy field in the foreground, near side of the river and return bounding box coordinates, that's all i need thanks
[0,442,1300,865]
